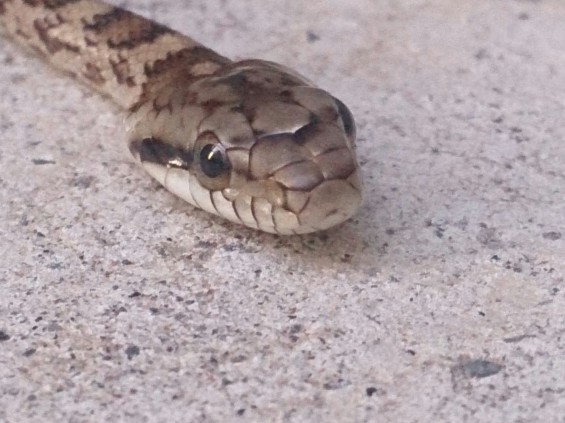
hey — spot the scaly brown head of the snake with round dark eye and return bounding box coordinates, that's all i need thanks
[128,60,362,234]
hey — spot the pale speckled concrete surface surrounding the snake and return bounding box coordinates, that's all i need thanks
[0,0,565,423]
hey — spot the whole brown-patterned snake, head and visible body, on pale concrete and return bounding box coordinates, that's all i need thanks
[0,0,363,235]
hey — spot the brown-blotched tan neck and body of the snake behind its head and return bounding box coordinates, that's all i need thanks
[0,0,231,109]
